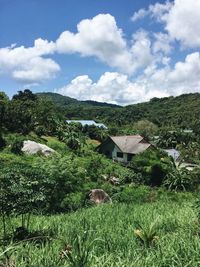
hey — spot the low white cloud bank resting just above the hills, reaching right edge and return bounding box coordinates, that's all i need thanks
[55,53,200,105]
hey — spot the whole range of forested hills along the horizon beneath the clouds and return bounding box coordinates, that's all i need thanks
[38,93,200,130]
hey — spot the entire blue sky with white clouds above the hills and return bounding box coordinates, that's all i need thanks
[0,0,200,105]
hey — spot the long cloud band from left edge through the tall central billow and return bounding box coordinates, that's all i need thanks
[0,14,157,83]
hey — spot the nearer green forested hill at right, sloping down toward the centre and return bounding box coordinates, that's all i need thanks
[116,93,200,128]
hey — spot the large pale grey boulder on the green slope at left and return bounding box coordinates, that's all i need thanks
[22,140,55,156]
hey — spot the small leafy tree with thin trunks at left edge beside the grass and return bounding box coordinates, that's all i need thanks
[0,164,49,240]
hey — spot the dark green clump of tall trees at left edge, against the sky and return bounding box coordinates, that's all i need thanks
[0,89,64,135]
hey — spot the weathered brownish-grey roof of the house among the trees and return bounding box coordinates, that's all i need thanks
[110,135,151,154]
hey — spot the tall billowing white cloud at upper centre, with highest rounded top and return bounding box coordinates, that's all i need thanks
[56,14,133,73]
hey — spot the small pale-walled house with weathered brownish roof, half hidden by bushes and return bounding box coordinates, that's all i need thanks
[98,135,152,163]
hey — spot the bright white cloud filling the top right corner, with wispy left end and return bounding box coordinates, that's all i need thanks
[132,0,200,48]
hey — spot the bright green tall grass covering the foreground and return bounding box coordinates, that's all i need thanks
[0,200,200,267]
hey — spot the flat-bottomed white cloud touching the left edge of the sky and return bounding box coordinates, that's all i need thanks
[0,39,60,83]
